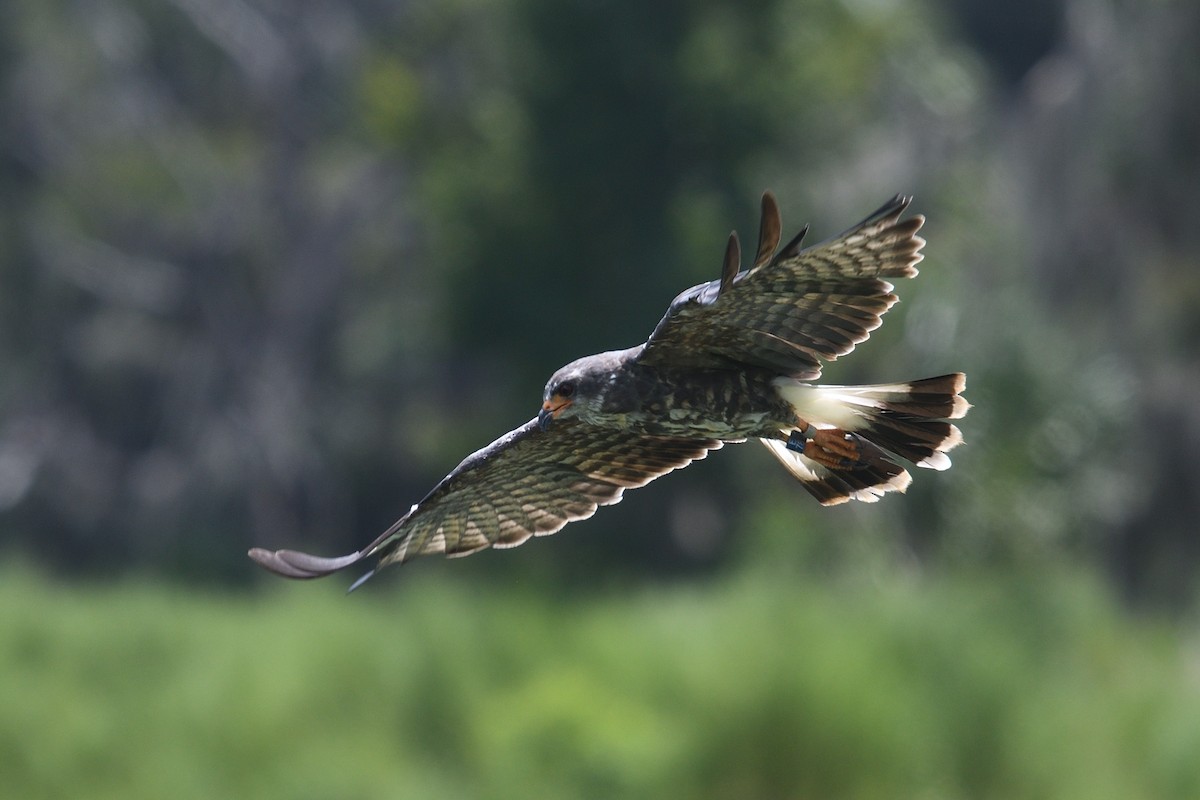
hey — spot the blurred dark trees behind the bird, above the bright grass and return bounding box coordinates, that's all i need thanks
[0,0,1200,604]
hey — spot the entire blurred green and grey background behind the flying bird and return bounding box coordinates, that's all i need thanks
[0,0,1200,800]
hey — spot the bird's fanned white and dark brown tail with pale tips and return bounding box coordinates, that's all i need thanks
[761,373,971,505]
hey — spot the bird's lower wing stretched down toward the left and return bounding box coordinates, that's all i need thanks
[250,420,722,578]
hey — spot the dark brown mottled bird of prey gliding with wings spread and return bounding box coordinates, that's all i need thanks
[250,192,970,588]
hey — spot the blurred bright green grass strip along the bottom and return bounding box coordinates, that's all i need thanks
[0,570,1200,800]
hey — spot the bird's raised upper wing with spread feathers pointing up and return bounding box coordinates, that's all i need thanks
[638,192,925,380]
